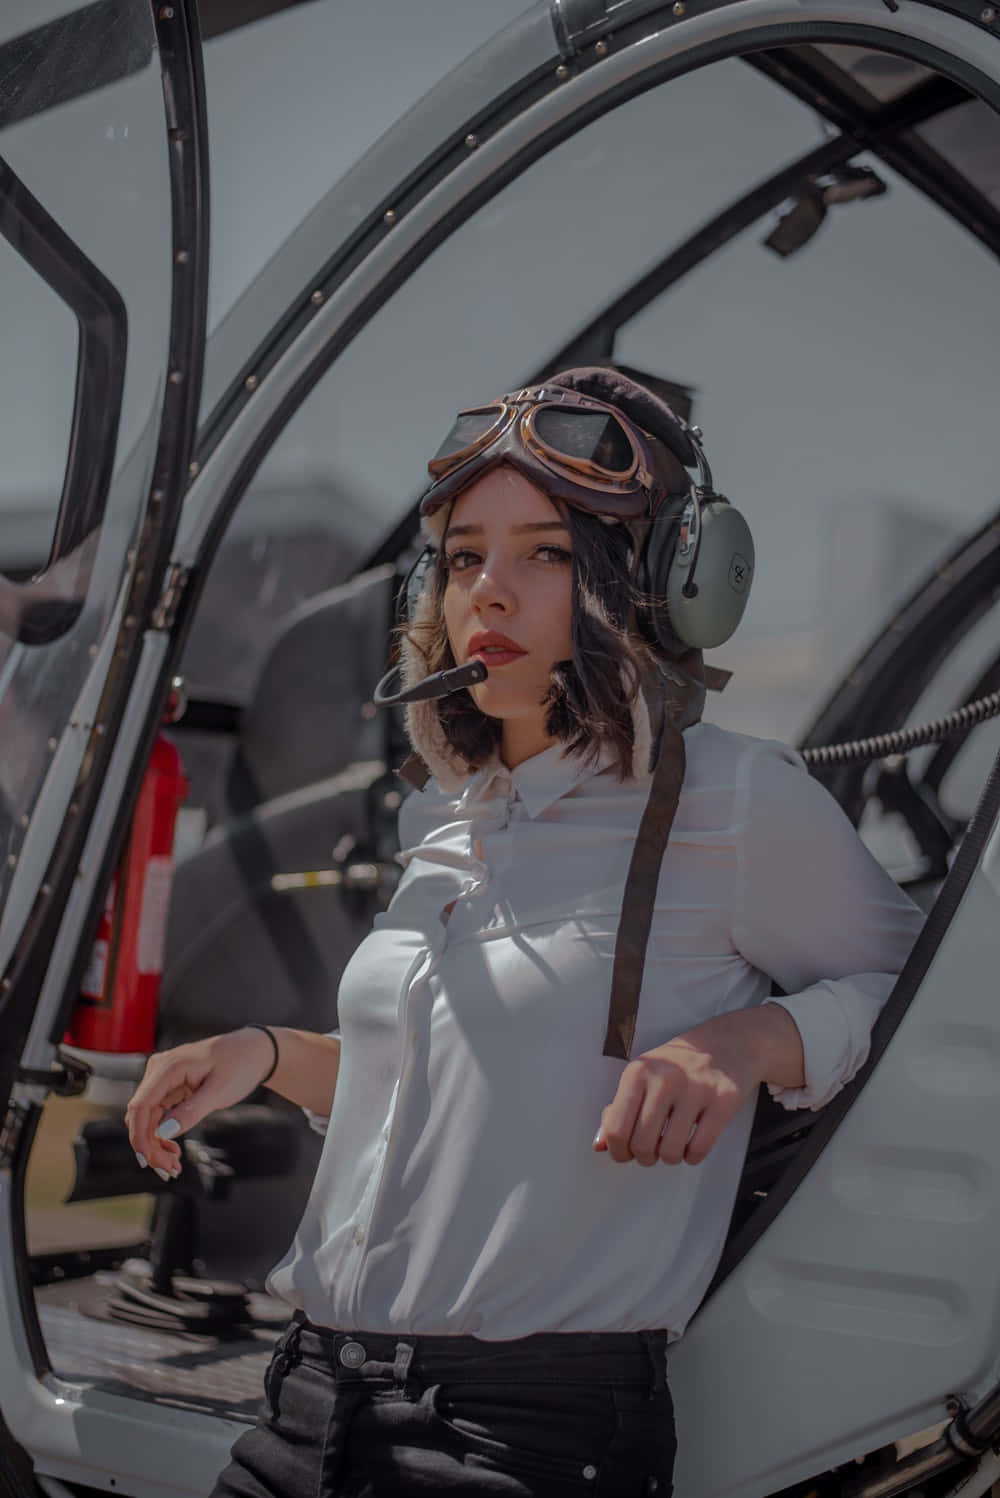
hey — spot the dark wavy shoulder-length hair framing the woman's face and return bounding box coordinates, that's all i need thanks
[400,500,656,780]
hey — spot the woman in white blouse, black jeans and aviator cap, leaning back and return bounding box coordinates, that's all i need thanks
[129,372,921,1498]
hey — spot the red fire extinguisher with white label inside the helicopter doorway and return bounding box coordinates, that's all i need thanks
[63,734,190,1055]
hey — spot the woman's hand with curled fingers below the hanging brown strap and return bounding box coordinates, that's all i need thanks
[594,1004,805,1165]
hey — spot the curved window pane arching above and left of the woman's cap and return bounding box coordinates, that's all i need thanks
[184,61,817,703]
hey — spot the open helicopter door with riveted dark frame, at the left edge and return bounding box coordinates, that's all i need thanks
[0,0,207,1480]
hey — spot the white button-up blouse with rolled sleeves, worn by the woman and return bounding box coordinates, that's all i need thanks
[268,724,922,1341]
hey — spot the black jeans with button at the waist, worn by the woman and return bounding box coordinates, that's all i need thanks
[213,1314,675,1498]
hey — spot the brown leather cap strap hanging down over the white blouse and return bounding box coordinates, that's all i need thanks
[603,718,686,1061]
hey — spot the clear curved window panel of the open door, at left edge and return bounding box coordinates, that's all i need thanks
[0,0,172,966]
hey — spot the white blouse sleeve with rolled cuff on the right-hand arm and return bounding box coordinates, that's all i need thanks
[734,742,924,1110]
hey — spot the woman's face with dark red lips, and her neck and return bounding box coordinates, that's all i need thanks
[443,464,573,768]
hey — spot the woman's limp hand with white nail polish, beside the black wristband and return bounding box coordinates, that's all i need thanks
[124,1029,281,1180]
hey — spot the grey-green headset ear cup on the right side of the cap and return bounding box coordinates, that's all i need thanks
[665,494,756,650]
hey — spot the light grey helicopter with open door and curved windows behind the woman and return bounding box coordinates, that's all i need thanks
[0,0,1000,1498]
